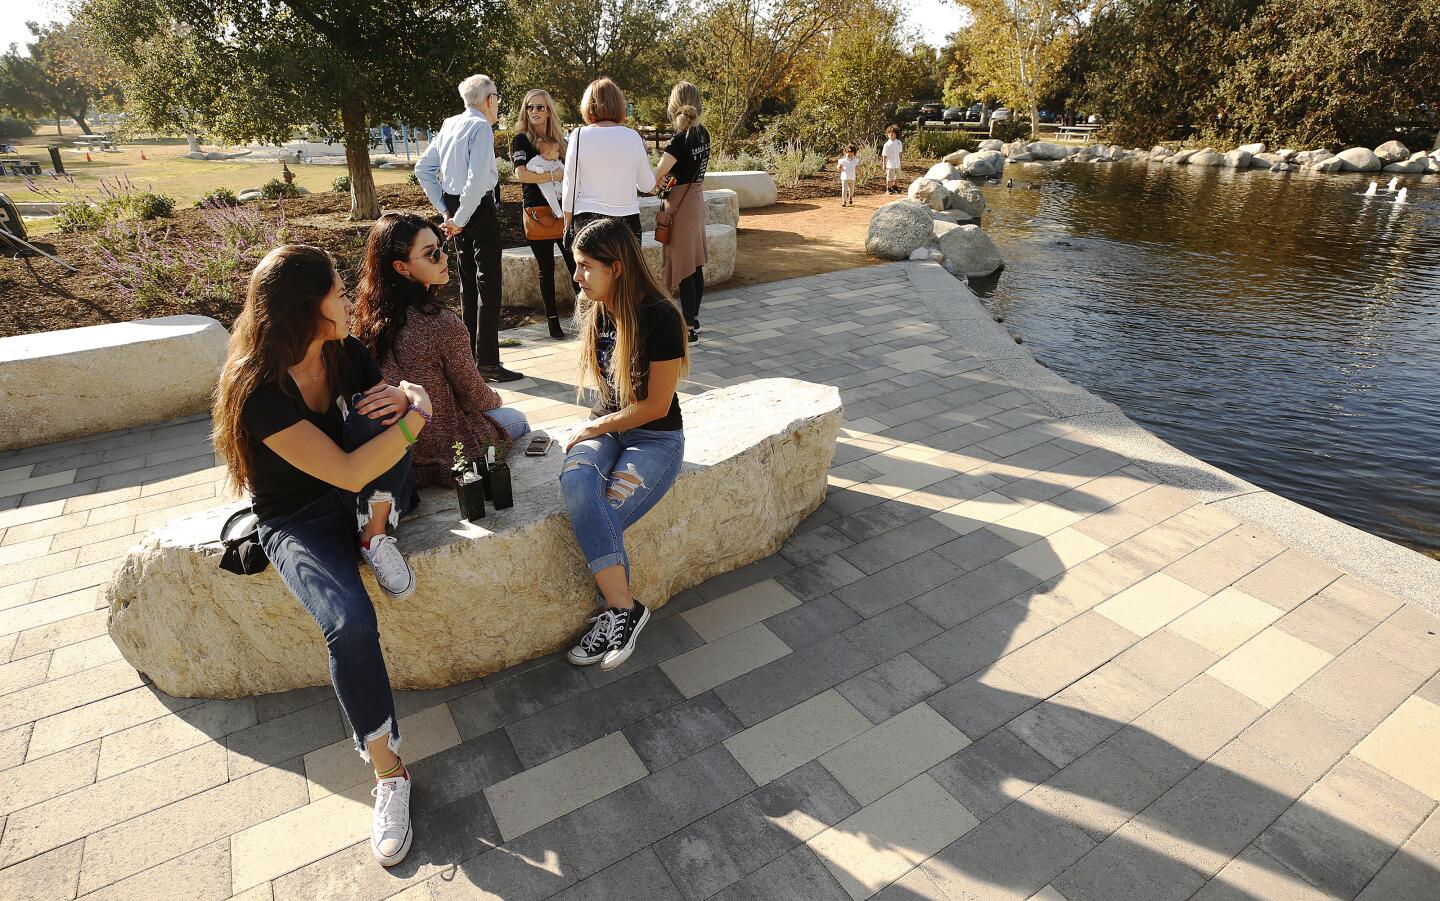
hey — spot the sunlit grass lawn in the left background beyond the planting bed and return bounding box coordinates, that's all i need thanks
[0,130,409,235]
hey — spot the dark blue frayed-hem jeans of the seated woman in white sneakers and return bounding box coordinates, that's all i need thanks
[259,403,415,763]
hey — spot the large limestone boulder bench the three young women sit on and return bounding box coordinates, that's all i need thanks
[108,379,842,698]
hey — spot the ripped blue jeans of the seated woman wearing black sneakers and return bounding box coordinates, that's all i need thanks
[560,429,685,579]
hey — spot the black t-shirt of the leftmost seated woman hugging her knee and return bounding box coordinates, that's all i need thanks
[242,337,382,521]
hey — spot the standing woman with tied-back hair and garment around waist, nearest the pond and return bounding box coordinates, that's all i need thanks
[655,82,710,343]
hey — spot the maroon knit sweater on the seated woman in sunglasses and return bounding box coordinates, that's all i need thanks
[380,308,508,488]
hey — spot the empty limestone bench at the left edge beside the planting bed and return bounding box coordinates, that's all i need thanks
[0,315,230,451]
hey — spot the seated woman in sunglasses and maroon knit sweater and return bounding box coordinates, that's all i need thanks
[354,213,530,486]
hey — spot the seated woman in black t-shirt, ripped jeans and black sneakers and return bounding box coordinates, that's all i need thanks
[560,219,690,669]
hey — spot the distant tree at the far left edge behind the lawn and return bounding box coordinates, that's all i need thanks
[0,22,122,134]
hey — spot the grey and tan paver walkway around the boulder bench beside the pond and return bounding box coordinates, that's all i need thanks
[0,263,1440,901]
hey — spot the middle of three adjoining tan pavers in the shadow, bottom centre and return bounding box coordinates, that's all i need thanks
[819,704,971,805]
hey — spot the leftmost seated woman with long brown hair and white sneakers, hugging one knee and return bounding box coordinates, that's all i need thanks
[213,245,431,866]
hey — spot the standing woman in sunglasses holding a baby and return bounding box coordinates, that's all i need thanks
[510,91,575,338]
